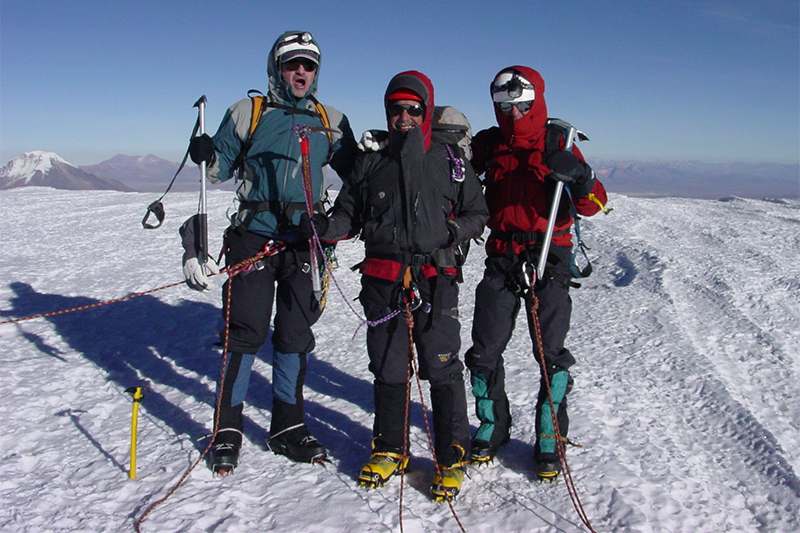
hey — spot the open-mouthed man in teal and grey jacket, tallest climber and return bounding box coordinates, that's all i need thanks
[184,31,358,473]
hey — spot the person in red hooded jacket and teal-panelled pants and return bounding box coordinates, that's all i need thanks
[465,66,607,481]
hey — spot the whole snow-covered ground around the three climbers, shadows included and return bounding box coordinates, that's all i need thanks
[0,188,800,533]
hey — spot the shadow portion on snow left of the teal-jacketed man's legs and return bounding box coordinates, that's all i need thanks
[0,282,219,446]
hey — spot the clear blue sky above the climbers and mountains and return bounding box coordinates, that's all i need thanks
[0,0,800,165]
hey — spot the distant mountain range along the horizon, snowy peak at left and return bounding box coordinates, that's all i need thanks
[0,151,800,199]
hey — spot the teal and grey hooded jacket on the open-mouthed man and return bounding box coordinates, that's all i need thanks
[208,32,358,242]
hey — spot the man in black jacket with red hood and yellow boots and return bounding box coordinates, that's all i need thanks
[324,71,488,500]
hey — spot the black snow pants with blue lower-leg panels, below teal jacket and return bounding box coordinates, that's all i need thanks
[218,231,322,435]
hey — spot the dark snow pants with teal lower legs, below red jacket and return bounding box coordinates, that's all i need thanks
[465,246,575,453]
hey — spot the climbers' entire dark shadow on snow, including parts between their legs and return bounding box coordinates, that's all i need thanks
[0,282,440,476]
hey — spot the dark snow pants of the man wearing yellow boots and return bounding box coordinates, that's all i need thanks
[359,274,470,466]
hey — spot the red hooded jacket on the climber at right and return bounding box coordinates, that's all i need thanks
[472,66,608,255]
